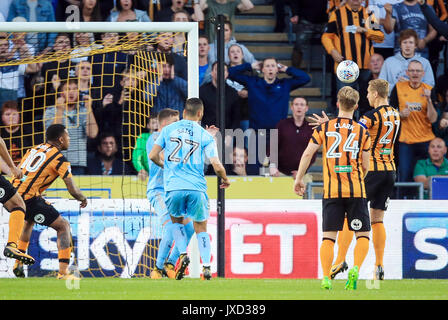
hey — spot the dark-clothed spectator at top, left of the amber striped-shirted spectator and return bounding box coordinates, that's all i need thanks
[290,0,328,68]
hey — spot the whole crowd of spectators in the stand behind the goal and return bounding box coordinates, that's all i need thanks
[0,0,448,199]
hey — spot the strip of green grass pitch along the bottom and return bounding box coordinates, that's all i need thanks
[0,278,448,301]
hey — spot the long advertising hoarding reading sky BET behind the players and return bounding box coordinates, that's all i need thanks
[0,199,448,279]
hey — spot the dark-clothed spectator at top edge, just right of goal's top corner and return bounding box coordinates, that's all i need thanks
[200,0,254,43]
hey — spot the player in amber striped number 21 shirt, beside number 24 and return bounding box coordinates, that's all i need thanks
[314,79,401,280]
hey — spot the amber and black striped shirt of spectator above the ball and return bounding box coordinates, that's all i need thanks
[321,4,384,70]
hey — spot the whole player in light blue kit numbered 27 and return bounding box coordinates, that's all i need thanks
[149,98,230,280]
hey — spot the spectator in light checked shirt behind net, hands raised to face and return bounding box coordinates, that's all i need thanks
[44,79,98,175]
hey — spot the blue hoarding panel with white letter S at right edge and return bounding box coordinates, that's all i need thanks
[402,213,448,279]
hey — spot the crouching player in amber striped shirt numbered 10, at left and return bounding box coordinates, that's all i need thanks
[12,124,87,279]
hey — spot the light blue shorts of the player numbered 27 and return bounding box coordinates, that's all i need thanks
[165,190,210,222]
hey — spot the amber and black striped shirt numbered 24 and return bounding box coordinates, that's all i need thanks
[310,118,371,199]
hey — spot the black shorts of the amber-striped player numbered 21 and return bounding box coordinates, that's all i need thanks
[364,171,397,210]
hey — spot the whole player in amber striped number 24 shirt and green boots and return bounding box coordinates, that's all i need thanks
[294,86,371,290]
